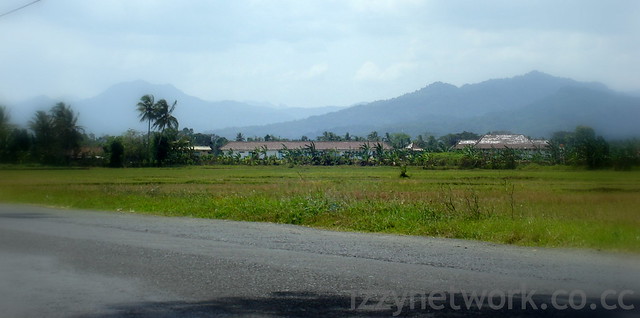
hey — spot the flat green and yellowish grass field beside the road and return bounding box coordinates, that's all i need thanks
[0,166,640,253]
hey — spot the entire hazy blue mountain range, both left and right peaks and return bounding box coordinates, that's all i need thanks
[9,71,640,138]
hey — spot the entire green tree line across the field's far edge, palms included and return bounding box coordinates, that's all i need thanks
[0,95,640,170]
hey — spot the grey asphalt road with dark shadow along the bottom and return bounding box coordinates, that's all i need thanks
[0,205,640,317]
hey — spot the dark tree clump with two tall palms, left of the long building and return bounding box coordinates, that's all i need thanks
[0,95,210,167]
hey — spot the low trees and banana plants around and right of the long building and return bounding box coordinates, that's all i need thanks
[202,126,640,170]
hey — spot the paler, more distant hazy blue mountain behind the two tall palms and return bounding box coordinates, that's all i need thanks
[9,81,341,135]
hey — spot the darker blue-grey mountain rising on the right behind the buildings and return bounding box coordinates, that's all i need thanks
[214,71,640,138]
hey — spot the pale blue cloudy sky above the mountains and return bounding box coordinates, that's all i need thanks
[0,0,640,107]
